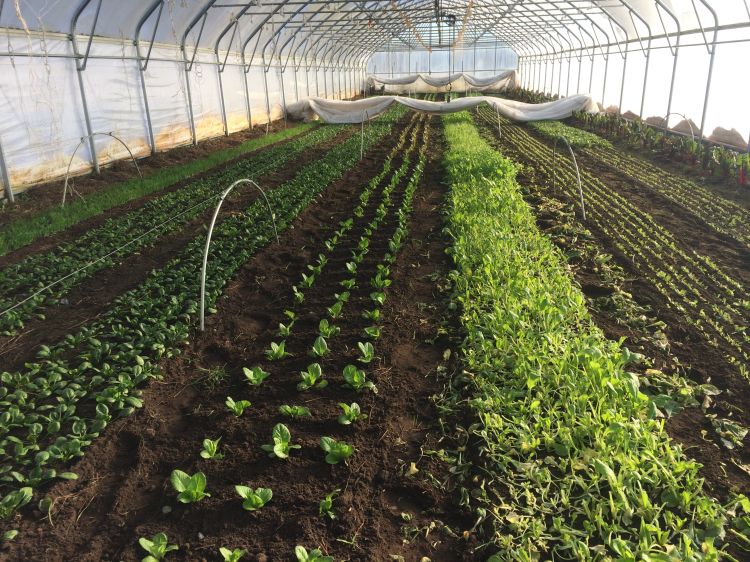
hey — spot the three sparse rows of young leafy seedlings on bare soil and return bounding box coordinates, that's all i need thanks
[119,117,429,562]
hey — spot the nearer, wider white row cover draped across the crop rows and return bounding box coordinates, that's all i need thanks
[287,94,599,123]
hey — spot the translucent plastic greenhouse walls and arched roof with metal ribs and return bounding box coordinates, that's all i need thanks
[0,0,750,199]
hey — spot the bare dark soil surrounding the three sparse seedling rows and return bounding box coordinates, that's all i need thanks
[2,118,473,562]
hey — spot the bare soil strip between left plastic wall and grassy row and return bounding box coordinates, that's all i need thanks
[0,120,294,226]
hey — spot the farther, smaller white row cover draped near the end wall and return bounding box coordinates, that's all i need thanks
[367,70,518,94]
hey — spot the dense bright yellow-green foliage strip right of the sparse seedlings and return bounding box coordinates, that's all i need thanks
[445,114,723,562]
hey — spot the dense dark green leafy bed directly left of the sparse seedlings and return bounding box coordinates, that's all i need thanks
[0,103,412,506]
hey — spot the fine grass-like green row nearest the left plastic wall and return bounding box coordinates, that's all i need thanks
[0,123,316,255]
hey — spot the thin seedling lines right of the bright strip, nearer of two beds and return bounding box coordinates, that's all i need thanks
[480,105,750,377]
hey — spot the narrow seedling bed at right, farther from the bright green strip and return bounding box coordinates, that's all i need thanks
[532,121,750,246]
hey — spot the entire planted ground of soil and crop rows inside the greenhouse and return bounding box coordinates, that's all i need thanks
[0,105,750,562]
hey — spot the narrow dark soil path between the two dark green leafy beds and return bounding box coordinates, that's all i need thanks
[0,128,354,370]
